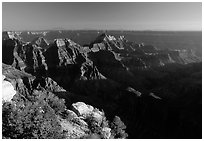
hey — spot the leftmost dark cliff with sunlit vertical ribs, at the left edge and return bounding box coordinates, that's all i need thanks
[2,39,47,74]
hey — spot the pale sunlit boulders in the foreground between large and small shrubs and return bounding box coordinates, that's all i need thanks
[57,102,112,139]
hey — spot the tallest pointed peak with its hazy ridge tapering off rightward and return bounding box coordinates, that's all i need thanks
[90,34,200,68]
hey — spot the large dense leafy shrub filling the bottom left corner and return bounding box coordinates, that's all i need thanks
[2,91,64,139]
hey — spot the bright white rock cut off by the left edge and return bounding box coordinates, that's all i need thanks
[2,75,16,102]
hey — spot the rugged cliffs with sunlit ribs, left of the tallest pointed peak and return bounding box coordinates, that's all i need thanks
[2,34,103,88]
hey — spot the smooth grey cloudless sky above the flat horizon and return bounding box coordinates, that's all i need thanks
[2,2,202,30]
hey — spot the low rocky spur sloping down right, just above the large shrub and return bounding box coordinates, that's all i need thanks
[2,64,65,96]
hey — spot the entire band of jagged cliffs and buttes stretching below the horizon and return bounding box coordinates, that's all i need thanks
[2,34,200,79]
